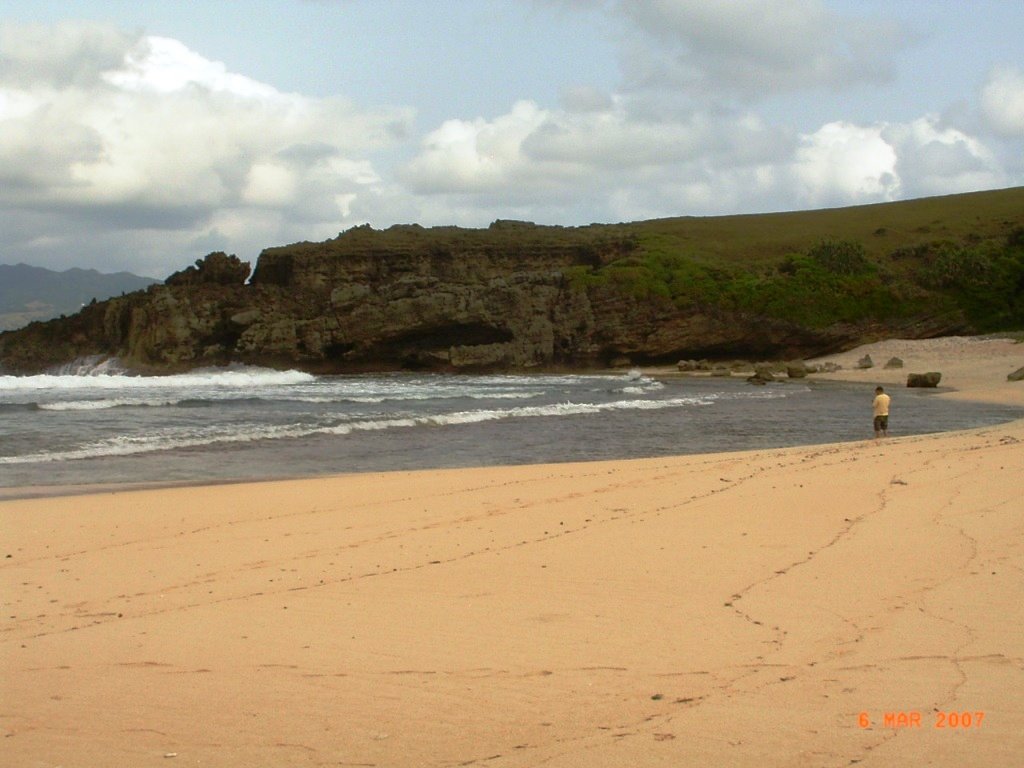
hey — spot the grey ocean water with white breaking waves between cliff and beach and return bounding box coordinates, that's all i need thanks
[0,364,1024,487]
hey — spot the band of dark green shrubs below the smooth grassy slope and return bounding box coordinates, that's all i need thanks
[566,219,1024,330]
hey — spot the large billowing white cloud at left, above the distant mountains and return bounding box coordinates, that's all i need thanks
[0,24,413,270]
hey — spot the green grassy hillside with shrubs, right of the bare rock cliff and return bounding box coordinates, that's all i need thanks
[571,187,1024,331]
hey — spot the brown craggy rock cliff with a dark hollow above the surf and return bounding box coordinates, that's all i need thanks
[0,222,983,373]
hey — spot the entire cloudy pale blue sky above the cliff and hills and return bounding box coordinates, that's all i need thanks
[0,0,1024,279]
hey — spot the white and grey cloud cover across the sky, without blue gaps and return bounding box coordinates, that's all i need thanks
[0,0,1024,276]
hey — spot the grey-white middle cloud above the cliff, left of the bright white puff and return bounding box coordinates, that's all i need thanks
[404,94,787,203]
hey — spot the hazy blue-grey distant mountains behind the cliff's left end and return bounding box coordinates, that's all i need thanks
[0,264,159,331]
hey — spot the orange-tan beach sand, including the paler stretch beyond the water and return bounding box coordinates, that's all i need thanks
[0,340,1024,768]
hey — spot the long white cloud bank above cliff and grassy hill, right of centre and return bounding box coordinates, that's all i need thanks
[399,91,1009,223]
